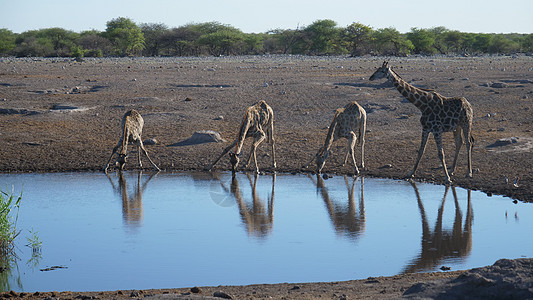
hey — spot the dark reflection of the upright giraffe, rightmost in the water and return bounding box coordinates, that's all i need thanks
[403,181,474,273]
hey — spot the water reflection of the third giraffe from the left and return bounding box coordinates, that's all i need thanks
[308,175,366,240]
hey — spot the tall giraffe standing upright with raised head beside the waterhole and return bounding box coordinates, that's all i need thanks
[370,61,474,184]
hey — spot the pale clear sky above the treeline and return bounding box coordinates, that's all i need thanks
[0,0,533,33]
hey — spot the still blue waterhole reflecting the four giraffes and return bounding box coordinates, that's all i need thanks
[0,172,533,292]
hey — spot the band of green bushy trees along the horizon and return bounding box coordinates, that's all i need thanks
[0,17,533,57]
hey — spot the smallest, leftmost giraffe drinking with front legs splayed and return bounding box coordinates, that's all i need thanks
[104,109,161,173]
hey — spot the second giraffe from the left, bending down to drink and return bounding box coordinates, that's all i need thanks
[205,100,276,174]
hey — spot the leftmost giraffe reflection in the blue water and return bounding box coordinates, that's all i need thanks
[106,171,157,227]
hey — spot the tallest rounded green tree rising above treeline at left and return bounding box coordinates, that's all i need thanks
[104,17,145,56]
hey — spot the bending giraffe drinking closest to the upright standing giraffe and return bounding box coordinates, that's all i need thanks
[304,101,366,175]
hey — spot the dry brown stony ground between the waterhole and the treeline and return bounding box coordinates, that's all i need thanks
[0,56,533,298]
